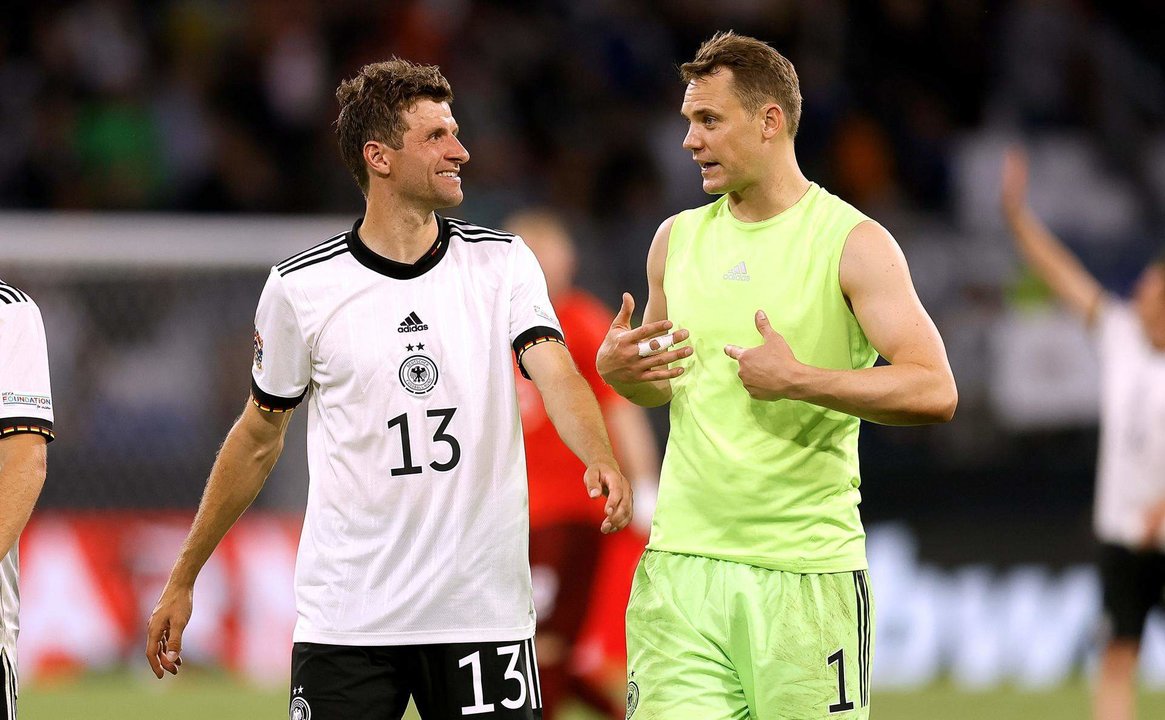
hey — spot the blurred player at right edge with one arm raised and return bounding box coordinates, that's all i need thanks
[1002,149,1165,720]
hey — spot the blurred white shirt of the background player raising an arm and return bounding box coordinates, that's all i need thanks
[1094,299,1165,550]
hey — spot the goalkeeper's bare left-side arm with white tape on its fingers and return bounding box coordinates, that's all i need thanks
[595,216,692,408]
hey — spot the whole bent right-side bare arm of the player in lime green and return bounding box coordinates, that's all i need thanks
[725,221,958,425]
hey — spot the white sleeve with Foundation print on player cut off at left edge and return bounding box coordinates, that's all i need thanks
[0,283,54,442]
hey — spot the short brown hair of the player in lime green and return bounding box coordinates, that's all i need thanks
[679,30,802,137]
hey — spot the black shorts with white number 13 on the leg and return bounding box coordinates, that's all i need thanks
[289,638,542,720]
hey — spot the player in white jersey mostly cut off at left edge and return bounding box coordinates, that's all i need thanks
[0,281,52,720]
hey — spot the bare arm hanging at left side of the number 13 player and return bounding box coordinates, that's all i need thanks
[146,401,291,678]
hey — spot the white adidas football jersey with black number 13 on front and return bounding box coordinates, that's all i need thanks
[252,216,563,645]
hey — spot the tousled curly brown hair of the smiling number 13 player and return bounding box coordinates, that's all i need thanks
[336,57,453,195]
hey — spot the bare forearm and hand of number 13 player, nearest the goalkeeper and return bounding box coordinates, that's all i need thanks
[522,343,631,532]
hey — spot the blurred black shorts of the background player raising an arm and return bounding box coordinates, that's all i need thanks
[1100,544,1165,641]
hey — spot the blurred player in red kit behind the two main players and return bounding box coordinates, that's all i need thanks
[503,210,659,720]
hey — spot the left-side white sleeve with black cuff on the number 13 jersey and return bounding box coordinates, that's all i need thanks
[250,268,311,412]
